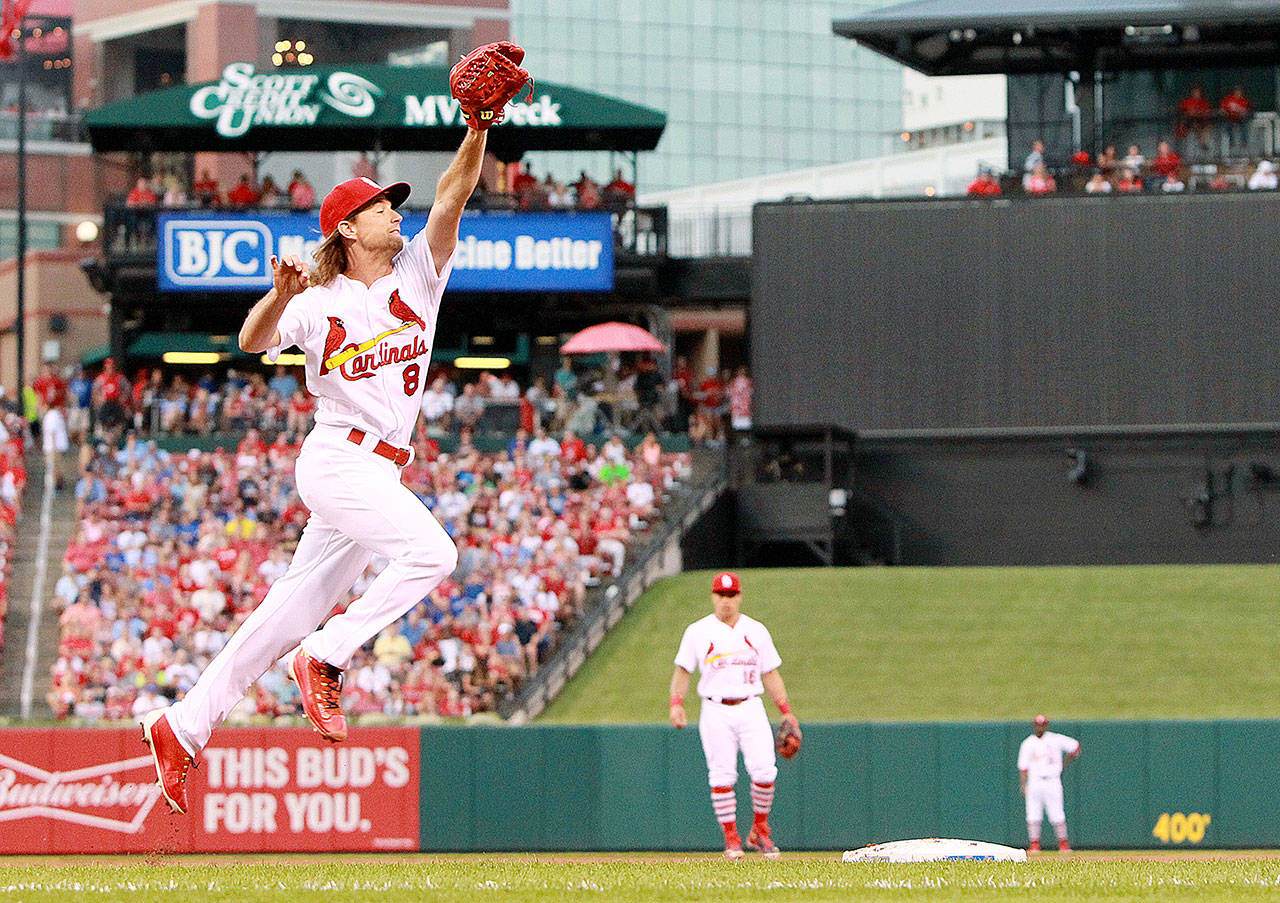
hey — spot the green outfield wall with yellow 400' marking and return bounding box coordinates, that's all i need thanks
[420,721,1280,850]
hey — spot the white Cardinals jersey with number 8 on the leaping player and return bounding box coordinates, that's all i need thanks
[270,228,453,446]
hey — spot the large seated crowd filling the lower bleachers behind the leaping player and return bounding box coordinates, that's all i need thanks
[47,425,690,721]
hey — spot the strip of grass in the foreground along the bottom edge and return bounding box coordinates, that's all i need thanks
[0,854,1280,903]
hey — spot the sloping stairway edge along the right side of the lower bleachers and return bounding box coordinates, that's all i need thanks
[498,450,728,724]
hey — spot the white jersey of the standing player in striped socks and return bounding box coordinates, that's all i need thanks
[676,612,782,699]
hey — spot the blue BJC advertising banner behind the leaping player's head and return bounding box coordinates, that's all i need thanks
[156,210,613,292]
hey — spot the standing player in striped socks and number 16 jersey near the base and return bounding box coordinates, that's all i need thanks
[671,571,800,859]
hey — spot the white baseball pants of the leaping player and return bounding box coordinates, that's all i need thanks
[169,425,458,754]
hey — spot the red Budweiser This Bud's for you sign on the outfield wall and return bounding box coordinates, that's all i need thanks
[0,728,419,853]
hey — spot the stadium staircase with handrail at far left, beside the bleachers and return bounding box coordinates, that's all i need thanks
[0,453,76,719]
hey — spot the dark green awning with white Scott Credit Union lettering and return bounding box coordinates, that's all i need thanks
[86,63,667,160]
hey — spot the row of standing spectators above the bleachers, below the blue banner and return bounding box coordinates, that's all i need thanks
[37,357,751,444]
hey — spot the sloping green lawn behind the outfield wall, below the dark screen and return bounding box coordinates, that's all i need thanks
[540,565,1280,724]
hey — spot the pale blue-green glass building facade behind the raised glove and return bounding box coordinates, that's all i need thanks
[511,0,902,191]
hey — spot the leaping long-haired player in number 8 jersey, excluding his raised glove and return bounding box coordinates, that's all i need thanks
[143,128,488,812]
